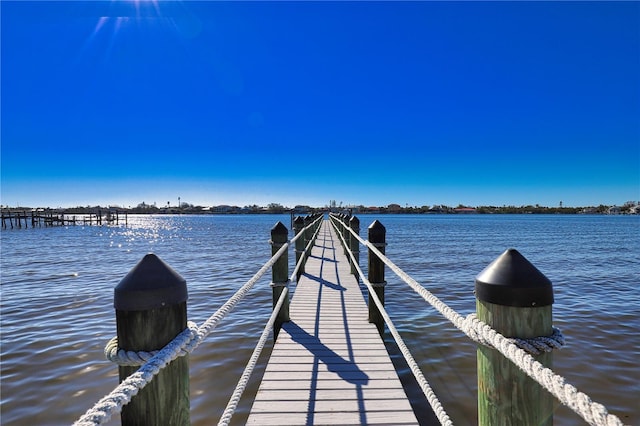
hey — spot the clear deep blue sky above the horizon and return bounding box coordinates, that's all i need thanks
[0,0,640,207]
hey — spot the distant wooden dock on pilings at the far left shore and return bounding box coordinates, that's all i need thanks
[0,209,127,229]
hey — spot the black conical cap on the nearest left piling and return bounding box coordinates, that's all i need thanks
[113,253,188,311]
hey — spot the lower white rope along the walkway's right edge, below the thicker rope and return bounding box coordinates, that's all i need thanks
[332,216,453,426]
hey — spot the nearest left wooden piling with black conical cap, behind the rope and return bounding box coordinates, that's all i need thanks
[114,254,190,426]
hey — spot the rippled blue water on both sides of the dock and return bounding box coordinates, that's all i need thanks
[0,215,640,425]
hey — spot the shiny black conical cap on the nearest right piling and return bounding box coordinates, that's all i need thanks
[476,249,553,307]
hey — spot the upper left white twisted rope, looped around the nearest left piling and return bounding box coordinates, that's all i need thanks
[74,216,322,426]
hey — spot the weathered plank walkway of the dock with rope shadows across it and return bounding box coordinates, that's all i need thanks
[247,221,418,425]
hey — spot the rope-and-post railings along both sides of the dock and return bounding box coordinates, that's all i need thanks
[75,214,622,425]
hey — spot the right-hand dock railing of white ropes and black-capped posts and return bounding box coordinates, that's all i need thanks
[330,214,623,426]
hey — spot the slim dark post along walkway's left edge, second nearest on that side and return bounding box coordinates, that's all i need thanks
[271,222,289,340]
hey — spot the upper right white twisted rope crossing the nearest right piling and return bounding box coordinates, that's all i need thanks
[332,215,623,426]
